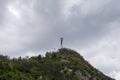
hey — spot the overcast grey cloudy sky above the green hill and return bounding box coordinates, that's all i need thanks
[0,0,120,80]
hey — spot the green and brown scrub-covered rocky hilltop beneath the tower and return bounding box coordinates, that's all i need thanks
[0,48,114,80]
